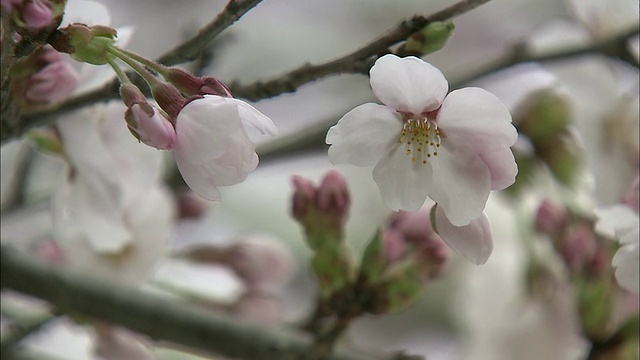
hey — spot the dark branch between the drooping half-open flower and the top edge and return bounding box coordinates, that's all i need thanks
[230,0,490,101]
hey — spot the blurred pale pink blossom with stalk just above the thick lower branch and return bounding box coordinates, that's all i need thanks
[179,235,294,324]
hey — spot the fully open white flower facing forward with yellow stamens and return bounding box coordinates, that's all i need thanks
[326,55,518,226]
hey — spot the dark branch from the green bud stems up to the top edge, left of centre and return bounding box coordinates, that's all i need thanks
[157,0,262,65]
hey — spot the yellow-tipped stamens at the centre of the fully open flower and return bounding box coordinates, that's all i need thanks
[399,114,441,164]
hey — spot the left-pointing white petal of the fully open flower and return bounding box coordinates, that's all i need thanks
[326,103,402,166]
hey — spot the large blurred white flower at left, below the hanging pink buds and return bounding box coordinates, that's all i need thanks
[53,101,174,282]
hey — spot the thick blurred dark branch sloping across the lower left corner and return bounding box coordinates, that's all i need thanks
[0,246,384,360]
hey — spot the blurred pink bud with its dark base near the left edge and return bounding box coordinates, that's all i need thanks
[11,46,80,107]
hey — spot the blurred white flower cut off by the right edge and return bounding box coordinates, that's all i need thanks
[595,205,640,294]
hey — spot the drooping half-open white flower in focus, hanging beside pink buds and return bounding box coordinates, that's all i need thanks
[173,95,276,201]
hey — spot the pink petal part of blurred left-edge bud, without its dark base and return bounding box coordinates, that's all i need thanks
[24,60,80,104]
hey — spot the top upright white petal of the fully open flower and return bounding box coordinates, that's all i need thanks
[370,54,449,115]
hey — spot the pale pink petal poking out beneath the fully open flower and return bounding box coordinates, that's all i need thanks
[436,206,493,265]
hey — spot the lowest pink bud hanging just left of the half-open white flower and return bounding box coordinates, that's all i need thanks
[125,102,176,150]
